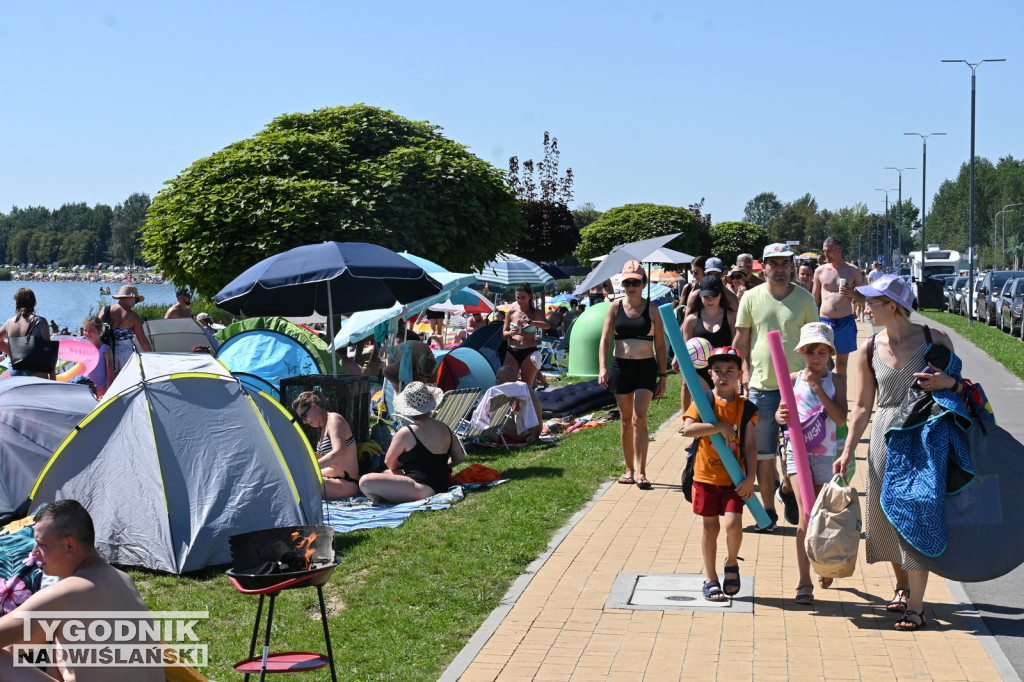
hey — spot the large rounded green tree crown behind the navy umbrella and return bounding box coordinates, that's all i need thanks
[143,104,522,294]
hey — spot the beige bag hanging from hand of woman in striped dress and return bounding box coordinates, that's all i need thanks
[804,476,860,578]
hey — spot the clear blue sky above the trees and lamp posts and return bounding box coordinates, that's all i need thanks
[0,0,1024,222]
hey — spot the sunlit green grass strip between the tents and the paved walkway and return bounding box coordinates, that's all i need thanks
[132,375,681,680]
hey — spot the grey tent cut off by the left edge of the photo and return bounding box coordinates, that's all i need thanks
[0,377,96,523]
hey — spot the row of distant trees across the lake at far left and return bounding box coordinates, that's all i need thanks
[0,193,151,267]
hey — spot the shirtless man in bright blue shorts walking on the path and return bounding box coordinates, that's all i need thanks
[811,237,867,375]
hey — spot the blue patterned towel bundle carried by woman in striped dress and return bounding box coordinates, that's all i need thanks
[882,343,975,556]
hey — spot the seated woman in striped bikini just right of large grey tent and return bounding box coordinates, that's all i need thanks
[292,391,359,500]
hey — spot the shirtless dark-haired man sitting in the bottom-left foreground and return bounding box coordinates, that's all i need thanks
[0,500,164,682]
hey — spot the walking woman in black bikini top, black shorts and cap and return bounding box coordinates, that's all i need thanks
[597,260,668,491]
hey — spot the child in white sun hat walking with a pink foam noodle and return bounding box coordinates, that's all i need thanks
[775,323,847,605]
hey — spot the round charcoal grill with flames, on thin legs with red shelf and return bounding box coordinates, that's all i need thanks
[227,525,339,682]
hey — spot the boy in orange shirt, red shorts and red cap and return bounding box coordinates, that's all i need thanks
[683,346,758,601]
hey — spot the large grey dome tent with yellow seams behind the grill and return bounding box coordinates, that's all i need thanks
[31,352,323,574]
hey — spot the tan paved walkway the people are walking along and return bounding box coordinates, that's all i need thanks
[441,325,1014,682]
